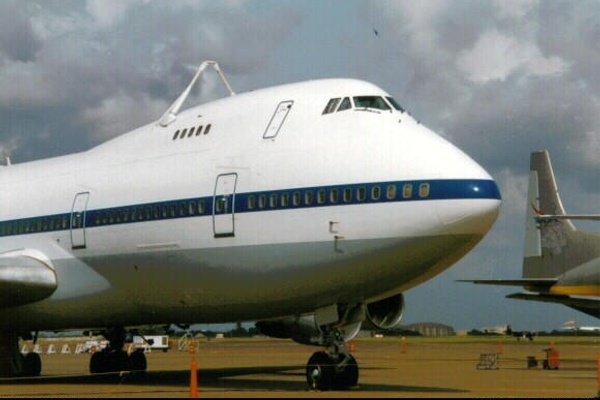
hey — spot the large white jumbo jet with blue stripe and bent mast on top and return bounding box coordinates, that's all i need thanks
[0,61,501,389]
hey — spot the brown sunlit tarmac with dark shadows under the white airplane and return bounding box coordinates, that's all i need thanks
[0,336,600,398]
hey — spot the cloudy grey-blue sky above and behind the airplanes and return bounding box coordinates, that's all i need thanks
[0,0,600,330]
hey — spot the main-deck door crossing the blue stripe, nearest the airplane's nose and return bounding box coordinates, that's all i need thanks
[213,173,237,238]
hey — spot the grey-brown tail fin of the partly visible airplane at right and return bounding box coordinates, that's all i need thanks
[523,150,600,279]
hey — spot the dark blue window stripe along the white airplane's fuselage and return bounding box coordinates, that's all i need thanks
[0,179,501,237]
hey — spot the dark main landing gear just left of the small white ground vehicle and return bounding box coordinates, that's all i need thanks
[90,327,147,374]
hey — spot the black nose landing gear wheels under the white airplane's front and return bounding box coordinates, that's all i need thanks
[306,333,358,390]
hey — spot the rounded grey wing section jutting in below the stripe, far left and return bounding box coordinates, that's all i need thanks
[0,254,58,308]
